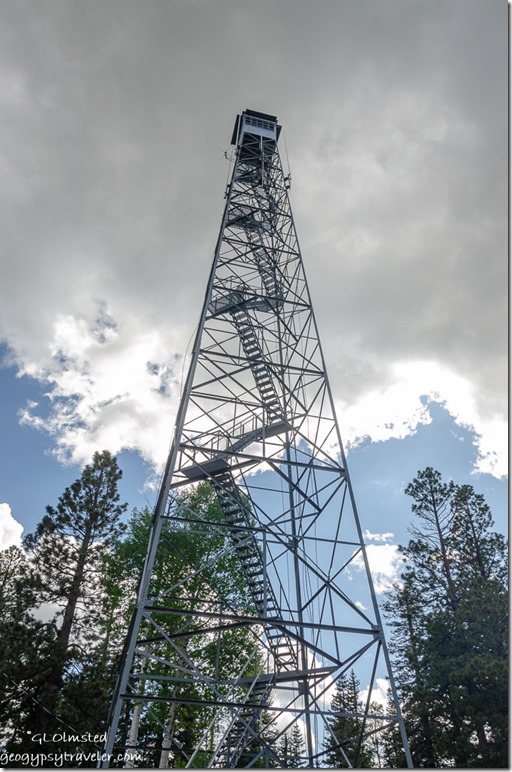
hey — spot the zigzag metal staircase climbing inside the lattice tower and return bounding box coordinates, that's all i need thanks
[198,176,299,768]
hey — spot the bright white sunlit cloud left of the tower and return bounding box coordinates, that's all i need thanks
[17,306,186,465]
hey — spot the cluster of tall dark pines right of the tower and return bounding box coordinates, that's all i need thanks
[386,467,508,768]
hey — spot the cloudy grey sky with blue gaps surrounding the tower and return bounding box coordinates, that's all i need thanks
[0,0,508,568]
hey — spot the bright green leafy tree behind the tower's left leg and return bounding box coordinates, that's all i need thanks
[102,483,268,767]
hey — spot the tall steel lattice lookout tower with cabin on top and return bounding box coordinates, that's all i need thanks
[105,110,412,768]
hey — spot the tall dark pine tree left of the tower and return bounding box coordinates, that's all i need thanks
[7,451,126,752]
